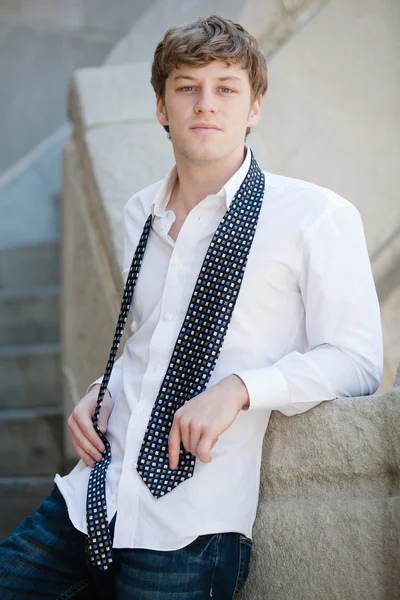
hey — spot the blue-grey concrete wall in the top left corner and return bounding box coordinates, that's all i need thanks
[0,0,153,174]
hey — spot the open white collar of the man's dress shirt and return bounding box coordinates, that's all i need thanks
[152,144,251,220]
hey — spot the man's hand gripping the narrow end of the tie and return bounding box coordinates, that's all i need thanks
[67,384,114,467]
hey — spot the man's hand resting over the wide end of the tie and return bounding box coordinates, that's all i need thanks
[168,375,249,469]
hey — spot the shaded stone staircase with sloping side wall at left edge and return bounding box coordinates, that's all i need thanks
[0,130,68,539]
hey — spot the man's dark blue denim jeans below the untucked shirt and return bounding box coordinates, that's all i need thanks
[0,485,252,600]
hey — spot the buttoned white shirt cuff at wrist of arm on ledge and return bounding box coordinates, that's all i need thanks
[233,366,289,410]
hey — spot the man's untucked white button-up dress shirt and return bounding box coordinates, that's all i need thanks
[55,144,383,550]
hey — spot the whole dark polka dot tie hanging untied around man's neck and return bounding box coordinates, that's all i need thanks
[86,153,264,571]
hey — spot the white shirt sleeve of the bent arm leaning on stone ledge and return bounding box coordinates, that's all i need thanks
[235,203,383,416]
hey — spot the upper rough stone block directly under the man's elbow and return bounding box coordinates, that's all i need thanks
[262,388,400,501]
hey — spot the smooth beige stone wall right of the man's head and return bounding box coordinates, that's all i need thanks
[259,0,400,254]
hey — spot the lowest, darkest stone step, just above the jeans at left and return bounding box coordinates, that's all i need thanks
[0,477,54,540]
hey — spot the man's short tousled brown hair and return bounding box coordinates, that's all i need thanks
[151,15,268,135]
